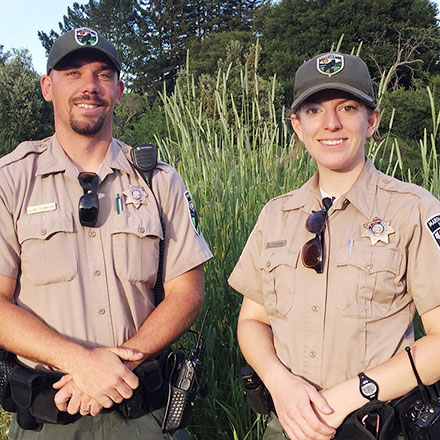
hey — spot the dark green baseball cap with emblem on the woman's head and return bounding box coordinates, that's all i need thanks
[292,52,376,111]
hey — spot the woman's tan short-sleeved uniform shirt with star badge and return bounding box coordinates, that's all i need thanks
[229,160,440,388]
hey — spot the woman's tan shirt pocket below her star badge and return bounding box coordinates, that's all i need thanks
[336,243,400,319]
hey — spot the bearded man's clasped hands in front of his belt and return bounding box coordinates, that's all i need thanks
[53,347,143,416]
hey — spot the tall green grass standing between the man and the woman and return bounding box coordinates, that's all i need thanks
[156,56,314,439]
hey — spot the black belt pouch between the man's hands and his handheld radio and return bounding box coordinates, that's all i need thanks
[116,359,167,419]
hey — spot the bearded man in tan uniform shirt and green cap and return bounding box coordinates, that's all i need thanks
[0,28,212,440]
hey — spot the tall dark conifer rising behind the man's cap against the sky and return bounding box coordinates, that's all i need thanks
[38,0,269,102]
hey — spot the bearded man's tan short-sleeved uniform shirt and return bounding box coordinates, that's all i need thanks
[0,136,212,364]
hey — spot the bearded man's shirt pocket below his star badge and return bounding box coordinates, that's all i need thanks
[111,211,163,288]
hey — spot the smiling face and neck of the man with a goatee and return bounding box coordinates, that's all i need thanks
[41,52,124,136]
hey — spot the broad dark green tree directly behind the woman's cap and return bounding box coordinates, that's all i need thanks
[254,0,440,102]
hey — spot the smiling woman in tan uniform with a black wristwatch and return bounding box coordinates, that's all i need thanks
[229,53,440,440]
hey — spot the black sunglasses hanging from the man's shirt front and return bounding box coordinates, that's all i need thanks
[78,172,99,228]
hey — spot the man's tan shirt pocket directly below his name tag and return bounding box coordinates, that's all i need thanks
[17,211,78,286]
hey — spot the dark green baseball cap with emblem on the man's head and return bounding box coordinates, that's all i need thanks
[47,27,121,75]
